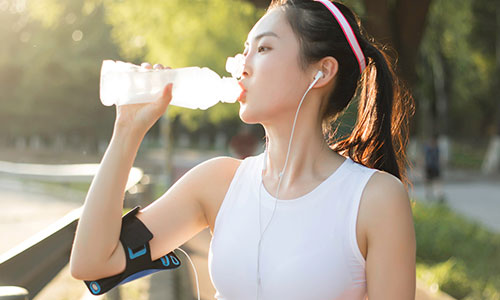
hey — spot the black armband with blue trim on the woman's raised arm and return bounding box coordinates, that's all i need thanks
[84,206,181,295]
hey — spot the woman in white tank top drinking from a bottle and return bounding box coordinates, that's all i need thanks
[71,0,416,300]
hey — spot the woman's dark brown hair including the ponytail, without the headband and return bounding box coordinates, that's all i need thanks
[268,0,414,188]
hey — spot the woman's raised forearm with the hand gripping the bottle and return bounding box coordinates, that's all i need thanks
[70,73,172,279]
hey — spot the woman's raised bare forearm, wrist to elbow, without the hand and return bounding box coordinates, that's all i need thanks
[70,126,147,279]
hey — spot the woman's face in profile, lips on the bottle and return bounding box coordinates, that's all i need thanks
[239,9,314,124]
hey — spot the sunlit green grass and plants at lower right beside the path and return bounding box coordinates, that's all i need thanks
[413,202,500,300]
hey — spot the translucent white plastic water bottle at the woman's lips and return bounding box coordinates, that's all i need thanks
[99,60,242,110]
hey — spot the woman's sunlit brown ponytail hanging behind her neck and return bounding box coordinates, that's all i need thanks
[331,41,414,190]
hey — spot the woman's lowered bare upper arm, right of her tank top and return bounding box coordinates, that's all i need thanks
[363,172,416,300]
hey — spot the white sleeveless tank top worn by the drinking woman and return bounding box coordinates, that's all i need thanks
[208,153,377,300]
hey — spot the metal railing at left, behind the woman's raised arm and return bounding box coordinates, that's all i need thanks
[0,162,153,300]
